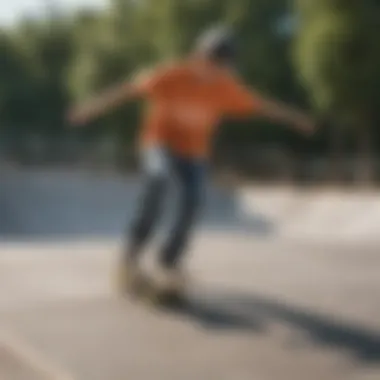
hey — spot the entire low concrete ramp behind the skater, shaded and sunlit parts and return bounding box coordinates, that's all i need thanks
[0,171,380,240]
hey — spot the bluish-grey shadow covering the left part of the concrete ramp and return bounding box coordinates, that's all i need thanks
[0,173,274,239]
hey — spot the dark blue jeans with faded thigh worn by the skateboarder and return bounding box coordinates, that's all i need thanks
[129,147,206,267]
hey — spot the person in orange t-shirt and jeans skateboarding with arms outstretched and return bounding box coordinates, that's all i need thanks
[70,27,313,302]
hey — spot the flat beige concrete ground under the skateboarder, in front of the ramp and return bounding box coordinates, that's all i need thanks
[0,236,380,380]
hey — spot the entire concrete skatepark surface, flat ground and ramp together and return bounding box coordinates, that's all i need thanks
[0,170,380,380]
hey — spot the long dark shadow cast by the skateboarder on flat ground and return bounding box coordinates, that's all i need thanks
[165,291,380,363]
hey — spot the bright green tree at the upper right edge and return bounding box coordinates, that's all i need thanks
[295,0,380,184]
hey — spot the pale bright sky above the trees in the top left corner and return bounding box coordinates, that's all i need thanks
[0,0,108,26]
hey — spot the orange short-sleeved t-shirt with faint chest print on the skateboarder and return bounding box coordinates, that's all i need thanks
[133,62,261,158]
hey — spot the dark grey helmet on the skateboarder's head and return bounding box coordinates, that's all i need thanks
[196,26,236,64]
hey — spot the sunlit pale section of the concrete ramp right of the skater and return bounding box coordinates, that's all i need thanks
[239,189,380,242]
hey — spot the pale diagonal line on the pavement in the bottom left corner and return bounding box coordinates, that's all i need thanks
[0,328,78,380]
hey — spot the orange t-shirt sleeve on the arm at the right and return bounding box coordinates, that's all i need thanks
[222,75,262,117]
